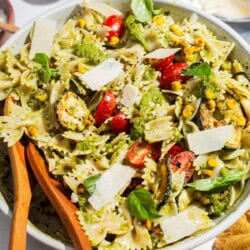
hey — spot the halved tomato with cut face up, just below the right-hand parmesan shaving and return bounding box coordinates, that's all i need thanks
[170,151,195,183]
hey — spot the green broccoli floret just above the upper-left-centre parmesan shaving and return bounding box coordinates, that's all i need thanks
[74,41,108,65]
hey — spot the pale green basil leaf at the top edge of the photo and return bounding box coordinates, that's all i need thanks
[130,0,153,23]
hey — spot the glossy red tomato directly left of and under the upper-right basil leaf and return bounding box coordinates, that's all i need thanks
[159,63,188,89]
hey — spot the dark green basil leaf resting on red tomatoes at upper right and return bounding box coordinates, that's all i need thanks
[183,63,212,78]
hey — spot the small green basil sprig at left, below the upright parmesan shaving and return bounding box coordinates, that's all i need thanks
[34,53,58,83]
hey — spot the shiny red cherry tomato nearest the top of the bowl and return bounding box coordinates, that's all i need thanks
[103,15,124,40]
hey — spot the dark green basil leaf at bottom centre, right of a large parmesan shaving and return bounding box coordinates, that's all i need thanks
[127,188,160,220]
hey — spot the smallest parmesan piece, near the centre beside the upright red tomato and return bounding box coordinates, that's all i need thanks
[121,84,141,107]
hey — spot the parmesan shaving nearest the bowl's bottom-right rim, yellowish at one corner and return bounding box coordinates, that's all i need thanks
[160,205,214,244]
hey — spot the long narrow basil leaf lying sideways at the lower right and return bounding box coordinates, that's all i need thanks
[186,170,246,192]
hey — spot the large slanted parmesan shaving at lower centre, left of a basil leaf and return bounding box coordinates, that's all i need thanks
[88,163,136,210]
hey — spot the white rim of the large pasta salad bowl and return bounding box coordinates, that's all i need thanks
[0,0,250,250]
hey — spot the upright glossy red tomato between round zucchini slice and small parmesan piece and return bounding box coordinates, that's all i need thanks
[94,90,116,126]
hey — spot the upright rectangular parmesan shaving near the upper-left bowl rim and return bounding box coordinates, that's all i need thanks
[29,20,56,60]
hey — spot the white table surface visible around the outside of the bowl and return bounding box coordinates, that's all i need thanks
[0,0,250,250]
